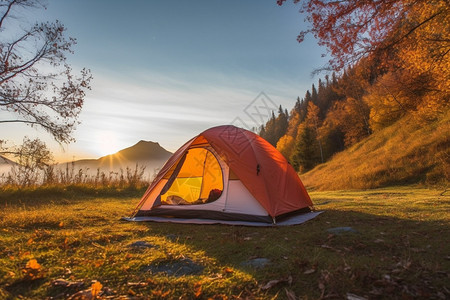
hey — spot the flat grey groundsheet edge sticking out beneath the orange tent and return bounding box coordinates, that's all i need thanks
[122,211,323,227]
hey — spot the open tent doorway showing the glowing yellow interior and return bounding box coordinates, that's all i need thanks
[161,148,223,205]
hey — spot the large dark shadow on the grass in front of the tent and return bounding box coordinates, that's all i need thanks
[137,210,450,299]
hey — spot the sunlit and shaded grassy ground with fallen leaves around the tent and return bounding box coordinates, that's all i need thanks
[0,187,450,299]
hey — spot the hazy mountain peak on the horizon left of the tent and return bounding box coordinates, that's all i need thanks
[59,141,172,176]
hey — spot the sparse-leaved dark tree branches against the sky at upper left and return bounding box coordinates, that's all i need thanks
[0,0,92,148]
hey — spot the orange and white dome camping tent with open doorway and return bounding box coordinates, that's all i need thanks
[125,125,318,226]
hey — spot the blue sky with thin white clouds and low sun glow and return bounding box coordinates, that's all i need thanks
[0,0,327,162]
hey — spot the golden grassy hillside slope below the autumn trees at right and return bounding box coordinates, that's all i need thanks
[300,113,450,190]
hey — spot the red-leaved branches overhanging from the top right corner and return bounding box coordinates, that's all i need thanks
[277,0,449,70]
